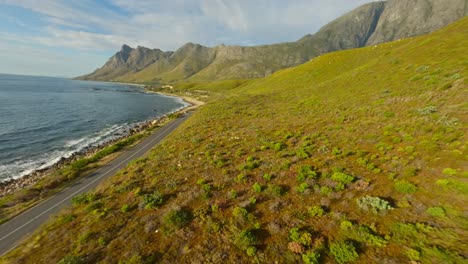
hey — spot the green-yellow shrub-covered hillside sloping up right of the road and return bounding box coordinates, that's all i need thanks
[4,18,468,263]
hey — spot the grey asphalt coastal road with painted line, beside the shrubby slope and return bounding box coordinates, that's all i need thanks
[0,113,190,255]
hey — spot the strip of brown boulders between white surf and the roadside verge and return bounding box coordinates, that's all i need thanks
[0,115,172,197]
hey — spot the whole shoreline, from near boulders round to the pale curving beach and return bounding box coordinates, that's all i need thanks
[0,92,204,198]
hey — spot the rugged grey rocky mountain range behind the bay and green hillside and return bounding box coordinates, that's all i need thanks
[77,0,468,83]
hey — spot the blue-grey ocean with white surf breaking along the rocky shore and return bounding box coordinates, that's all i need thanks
[0,74,186,182]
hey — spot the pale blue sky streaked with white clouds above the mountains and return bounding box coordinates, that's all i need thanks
[0,0,372,77]
